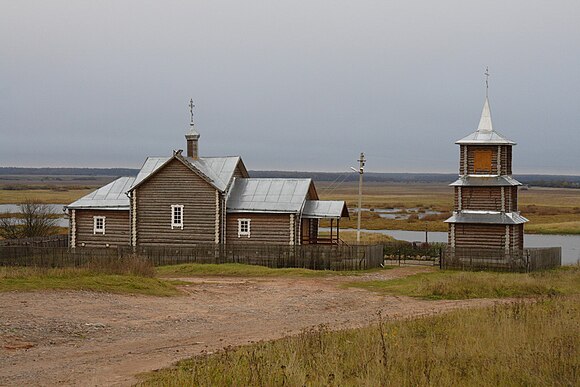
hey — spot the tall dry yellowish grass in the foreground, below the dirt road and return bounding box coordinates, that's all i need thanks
[140,296,580,387]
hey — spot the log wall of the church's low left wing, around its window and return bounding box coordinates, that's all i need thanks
[75,210,131,247]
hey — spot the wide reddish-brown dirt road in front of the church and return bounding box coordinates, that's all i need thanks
[0,267,506,386]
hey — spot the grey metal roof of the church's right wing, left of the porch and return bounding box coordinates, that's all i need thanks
[226,178,312,213]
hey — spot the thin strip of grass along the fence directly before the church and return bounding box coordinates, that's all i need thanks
[157,263,384,277]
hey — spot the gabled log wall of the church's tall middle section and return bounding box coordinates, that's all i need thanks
[137,160,220,246]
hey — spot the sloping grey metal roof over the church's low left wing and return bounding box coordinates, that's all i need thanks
[65,177,135,210]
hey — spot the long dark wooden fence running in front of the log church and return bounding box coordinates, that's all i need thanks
[0,245,383,270]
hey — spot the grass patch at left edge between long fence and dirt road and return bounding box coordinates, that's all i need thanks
[0,267,180,297]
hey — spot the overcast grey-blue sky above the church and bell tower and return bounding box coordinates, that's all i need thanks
[0,0,580,175]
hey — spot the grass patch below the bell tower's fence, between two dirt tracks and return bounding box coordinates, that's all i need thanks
[346,266,580,300]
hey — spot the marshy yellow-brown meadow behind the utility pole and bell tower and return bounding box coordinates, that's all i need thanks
[318,183,580,234]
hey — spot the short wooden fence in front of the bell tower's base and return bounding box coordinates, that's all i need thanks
[440,247,562,272]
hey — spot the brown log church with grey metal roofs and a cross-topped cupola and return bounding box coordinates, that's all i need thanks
[66,102,349,248]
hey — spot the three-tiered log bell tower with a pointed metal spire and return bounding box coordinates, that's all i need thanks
[445,90,528,257]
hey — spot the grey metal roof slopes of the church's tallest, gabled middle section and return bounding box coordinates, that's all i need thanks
[131,156,240,192]
